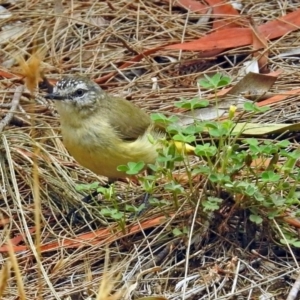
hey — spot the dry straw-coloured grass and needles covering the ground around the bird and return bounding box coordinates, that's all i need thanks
[0,0,300,299]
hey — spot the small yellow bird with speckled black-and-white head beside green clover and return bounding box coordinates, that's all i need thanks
[46,76,193,180]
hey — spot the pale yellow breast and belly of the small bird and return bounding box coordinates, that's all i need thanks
[62,122,157,178]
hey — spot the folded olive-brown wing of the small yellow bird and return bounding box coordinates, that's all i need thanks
[108,97,151,141]
